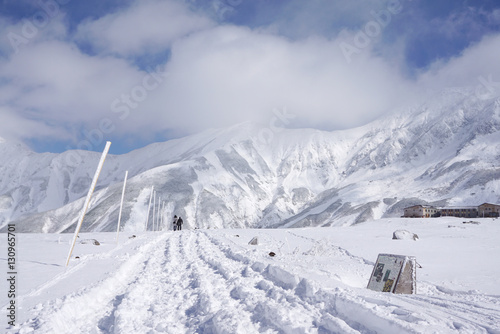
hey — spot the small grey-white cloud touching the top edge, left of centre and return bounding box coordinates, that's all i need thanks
[76,0,213,56]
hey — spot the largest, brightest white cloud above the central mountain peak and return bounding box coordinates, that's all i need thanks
[129,26,410,130]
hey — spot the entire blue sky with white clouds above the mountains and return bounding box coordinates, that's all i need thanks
[0,0,500,153]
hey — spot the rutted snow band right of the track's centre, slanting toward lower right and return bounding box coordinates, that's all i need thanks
[194,234,368,333]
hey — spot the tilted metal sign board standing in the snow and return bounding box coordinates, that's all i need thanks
[368,254,416,294]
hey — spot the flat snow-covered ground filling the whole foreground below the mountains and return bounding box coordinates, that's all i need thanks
[0,218,500,333]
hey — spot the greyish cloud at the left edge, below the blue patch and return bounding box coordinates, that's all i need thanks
[0,41,143,136]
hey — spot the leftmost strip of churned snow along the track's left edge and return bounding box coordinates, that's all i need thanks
[21,234,167,333]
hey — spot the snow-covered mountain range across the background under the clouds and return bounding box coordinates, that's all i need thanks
[0,89,500,232]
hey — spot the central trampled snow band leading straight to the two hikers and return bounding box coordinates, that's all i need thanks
[99,231,257,333]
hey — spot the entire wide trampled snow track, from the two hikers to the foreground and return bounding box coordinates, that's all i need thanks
[20,231,500,333]
